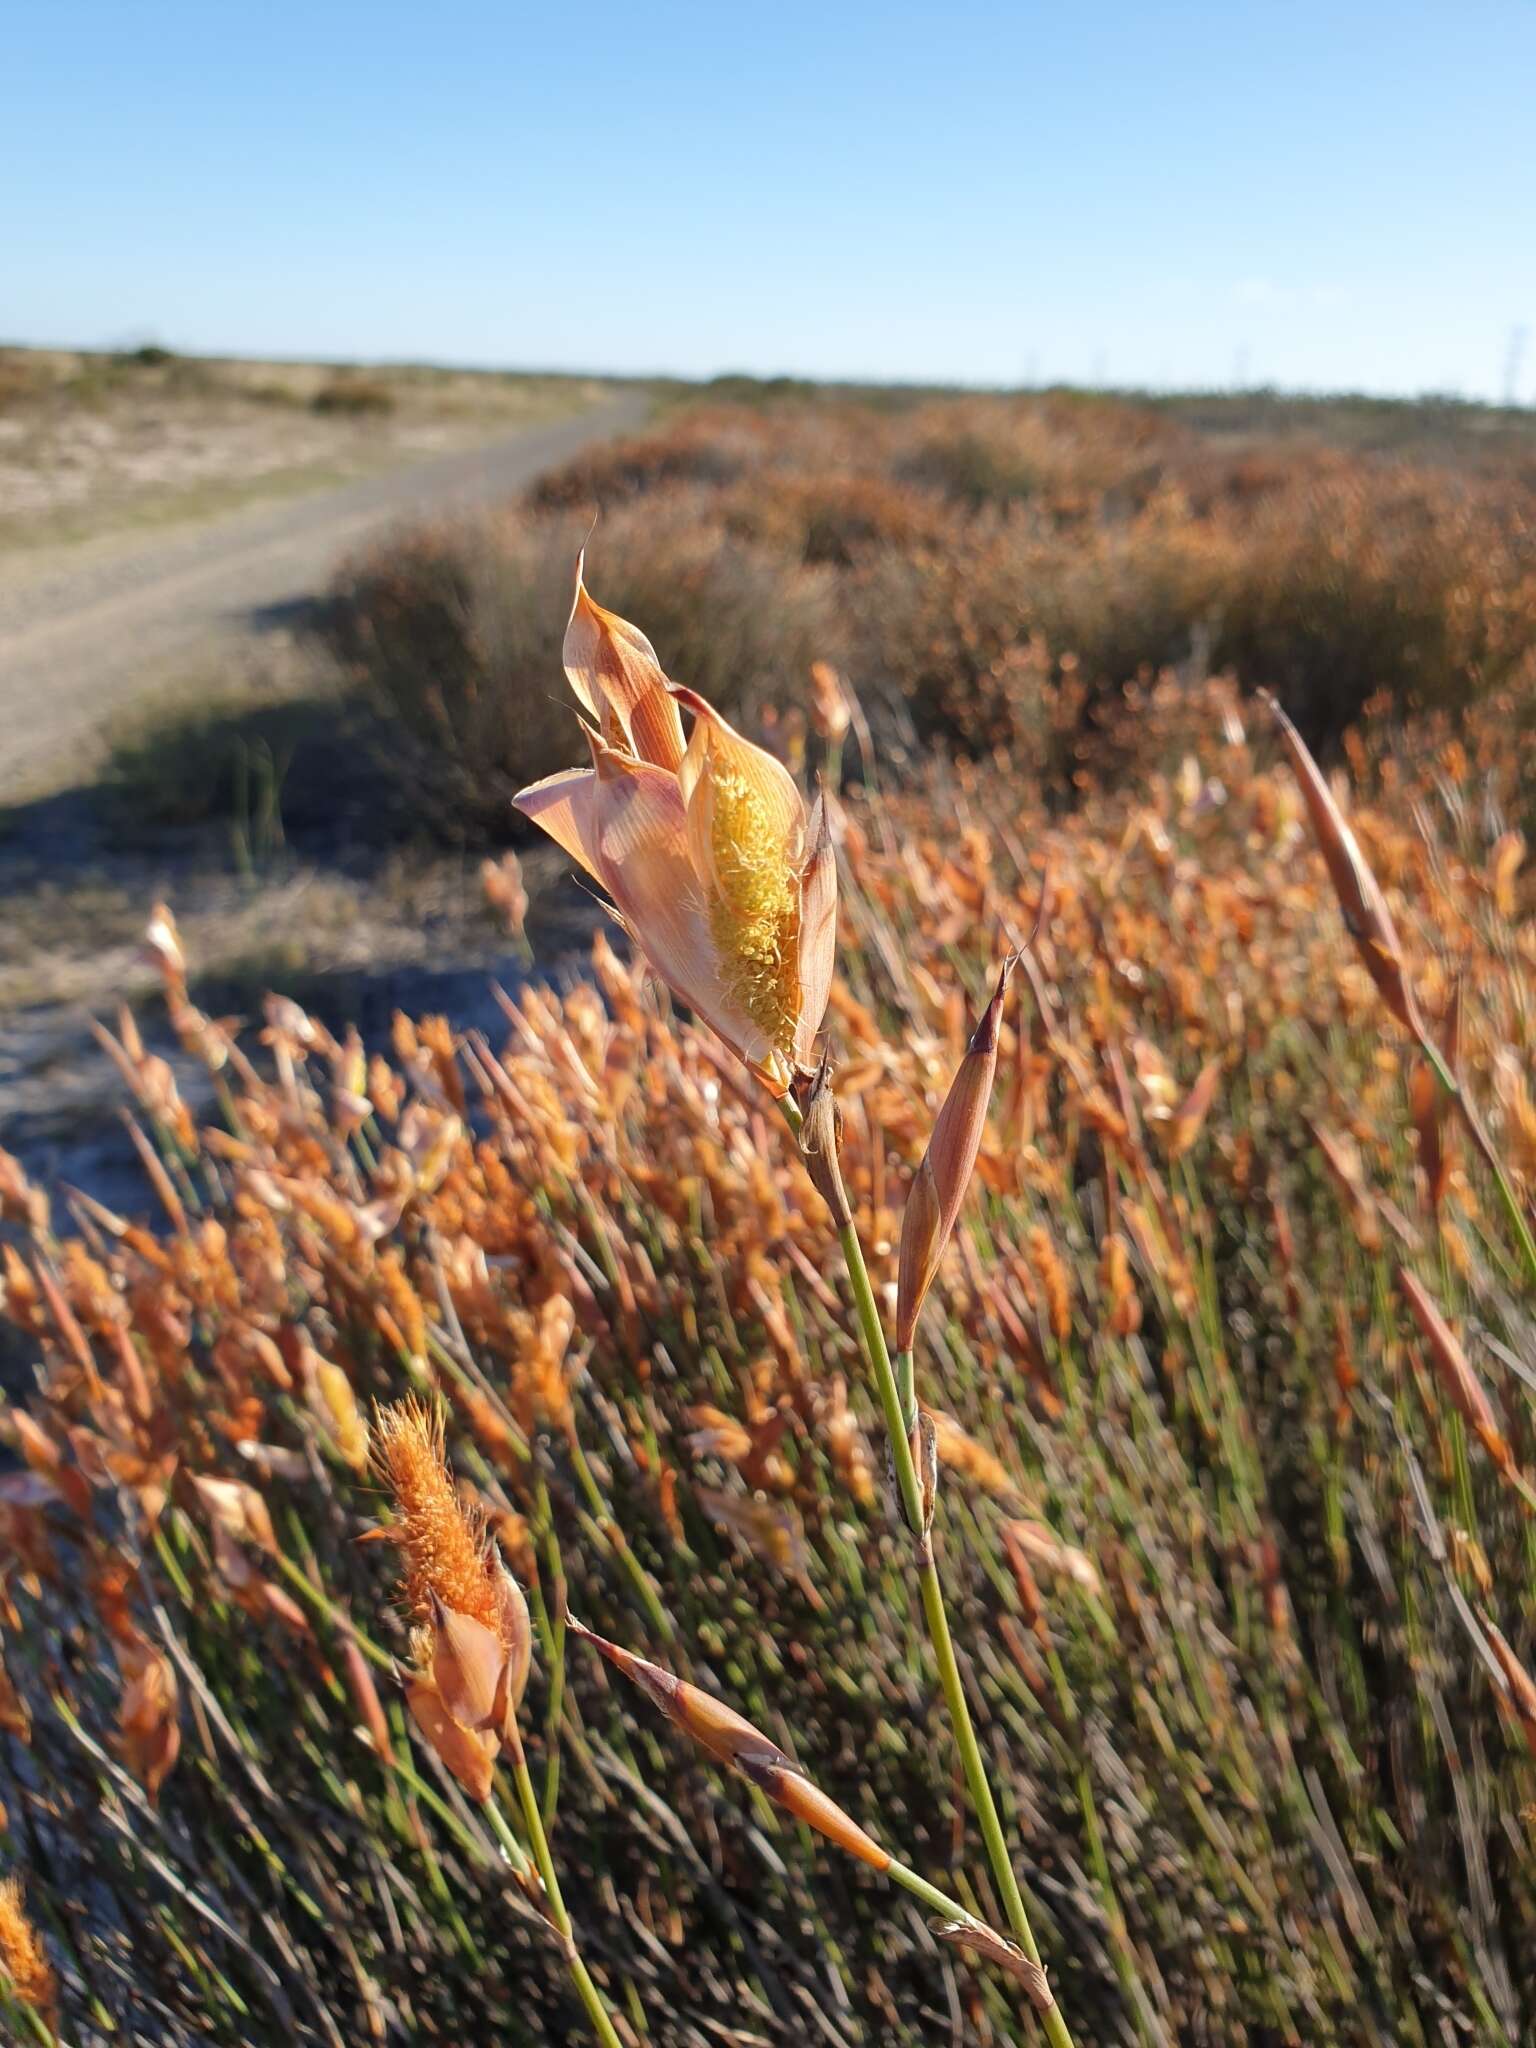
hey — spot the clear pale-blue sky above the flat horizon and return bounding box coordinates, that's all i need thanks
[0,0,1536,401]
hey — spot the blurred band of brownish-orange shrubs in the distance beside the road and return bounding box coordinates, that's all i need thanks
[336,393,1536,829]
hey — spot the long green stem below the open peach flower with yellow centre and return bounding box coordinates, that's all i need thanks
[838,1223,1071,2048]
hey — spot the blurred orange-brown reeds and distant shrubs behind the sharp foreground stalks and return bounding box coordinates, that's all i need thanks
[0,387,1536,2048]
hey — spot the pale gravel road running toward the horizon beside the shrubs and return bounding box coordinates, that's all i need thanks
[0,391,647,803]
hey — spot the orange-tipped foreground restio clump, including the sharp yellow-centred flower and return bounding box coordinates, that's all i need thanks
[0,495,1536,2048]
